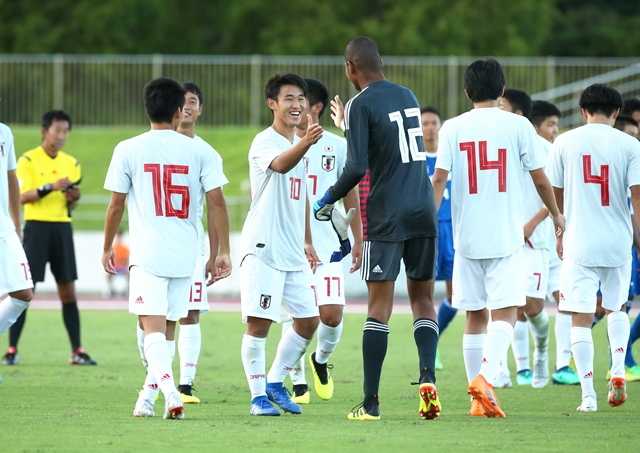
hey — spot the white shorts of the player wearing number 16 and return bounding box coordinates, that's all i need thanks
[129,266,191,321]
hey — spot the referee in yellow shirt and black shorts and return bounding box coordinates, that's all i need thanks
[2,110,96,365]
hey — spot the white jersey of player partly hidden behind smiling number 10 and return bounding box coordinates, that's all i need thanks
[303,131,347,264]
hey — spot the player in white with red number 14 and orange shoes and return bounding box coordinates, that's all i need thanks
[432,59,564,417]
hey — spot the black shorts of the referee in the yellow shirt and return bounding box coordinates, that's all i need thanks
[22,220,78,283]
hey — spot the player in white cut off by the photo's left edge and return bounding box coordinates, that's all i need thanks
[0,117,33,381]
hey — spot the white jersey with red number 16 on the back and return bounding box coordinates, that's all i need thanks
[104,130,226,278]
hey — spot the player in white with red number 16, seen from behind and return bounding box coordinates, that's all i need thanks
[102,77,231,419]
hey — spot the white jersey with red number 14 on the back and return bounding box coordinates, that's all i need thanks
[436,107,546,259]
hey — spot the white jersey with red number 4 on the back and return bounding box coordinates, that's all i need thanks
[548,124,640,267]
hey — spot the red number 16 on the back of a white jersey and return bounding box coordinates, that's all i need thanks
[144,164,191,219]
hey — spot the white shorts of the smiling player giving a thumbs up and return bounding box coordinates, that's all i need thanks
[240,255,320,322]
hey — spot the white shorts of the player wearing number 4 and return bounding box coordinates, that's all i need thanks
[558,257,631,313]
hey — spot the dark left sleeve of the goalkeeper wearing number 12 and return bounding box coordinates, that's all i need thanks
[331,98,370,200]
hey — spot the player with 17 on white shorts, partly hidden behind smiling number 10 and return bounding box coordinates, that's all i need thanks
[282,79,362,404]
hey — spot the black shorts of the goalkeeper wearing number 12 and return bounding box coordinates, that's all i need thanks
[360,238,438,282]
